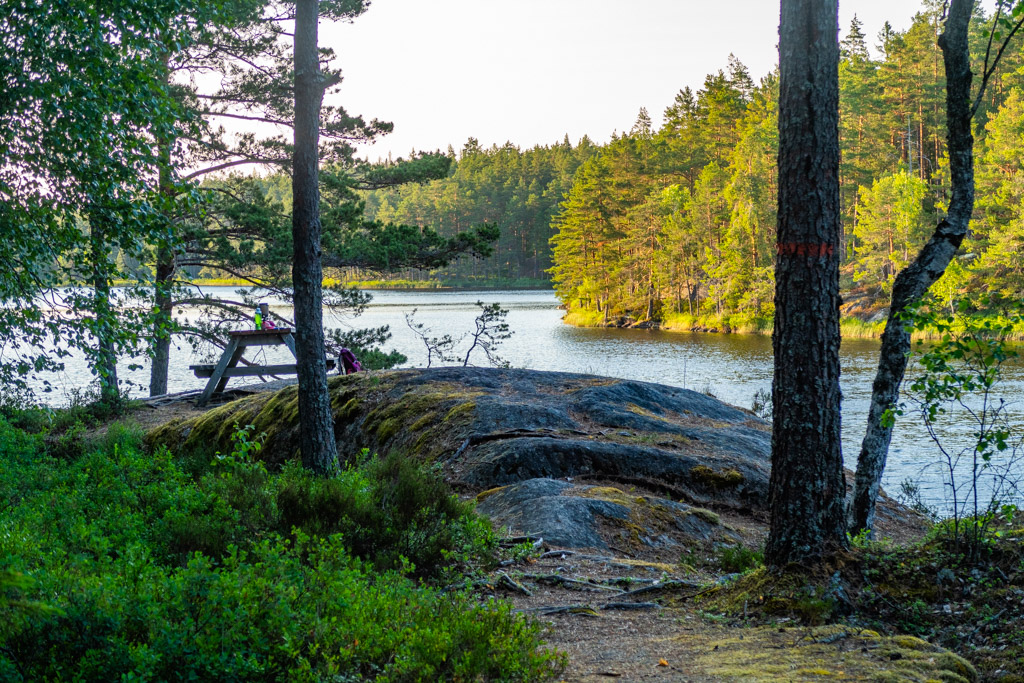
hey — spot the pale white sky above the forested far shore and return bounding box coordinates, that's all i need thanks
[319,0,937,159]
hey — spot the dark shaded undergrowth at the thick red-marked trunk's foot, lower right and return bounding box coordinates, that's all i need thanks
[698,520,1024,683]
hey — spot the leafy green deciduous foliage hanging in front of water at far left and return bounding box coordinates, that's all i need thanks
[0,0,210,400]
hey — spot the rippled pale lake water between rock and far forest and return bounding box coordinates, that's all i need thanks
[28,288,1024,507]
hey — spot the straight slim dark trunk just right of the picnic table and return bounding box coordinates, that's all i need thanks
[292,0,338,475]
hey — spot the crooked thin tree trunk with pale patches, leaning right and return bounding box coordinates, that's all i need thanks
[850,0,976,532]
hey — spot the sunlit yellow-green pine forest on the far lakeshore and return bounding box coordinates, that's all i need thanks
[366,0,1024,330]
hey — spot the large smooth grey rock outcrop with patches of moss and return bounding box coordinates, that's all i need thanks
[150,368,770,548]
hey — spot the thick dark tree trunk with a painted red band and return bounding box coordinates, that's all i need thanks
[765,0,846,566]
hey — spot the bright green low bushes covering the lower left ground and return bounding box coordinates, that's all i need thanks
[0,418,563,682]
